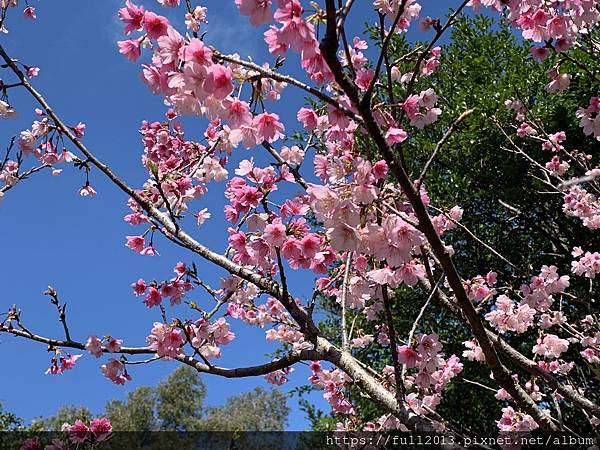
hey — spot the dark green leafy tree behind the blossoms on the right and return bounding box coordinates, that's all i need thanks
[302,16,600,435]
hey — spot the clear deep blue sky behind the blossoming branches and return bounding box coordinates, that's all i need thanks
[0,0,456,430]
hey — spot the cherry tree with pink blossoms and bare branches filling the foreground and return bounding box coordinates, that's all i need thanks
[0,0,600,436]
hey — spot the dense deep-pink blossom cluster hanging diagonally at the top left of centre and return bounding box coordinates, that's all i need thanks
[119,1,289,149]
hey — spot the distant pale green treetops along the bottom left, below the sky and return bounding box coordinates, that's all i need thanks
[38,366,290,431]
